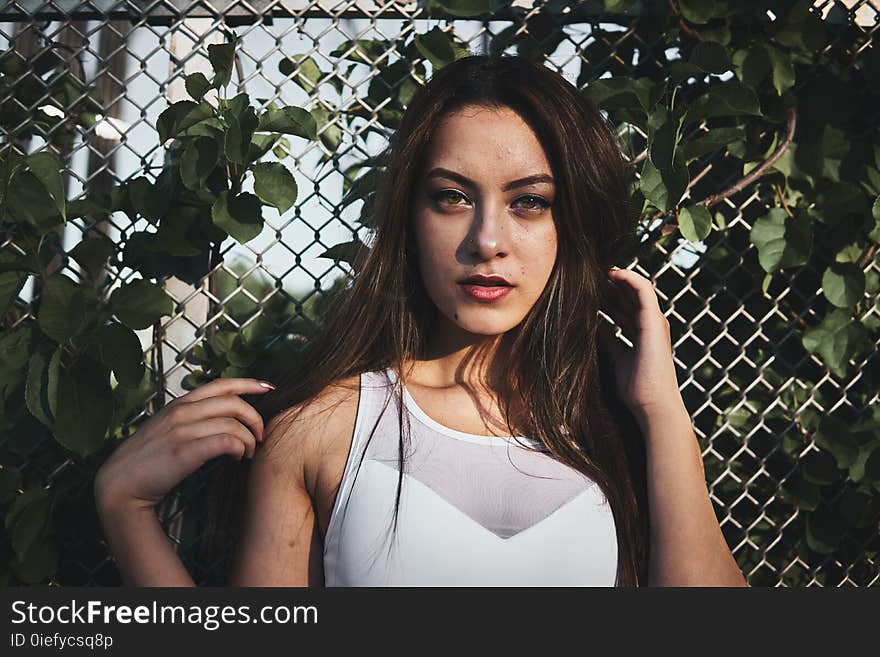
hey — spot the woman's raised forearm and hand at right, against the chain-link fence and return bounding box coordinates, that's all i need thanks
[599,268,747,586]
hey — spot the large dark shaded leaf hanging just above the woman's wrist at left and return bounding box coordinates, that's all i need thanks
[53,357,113,456]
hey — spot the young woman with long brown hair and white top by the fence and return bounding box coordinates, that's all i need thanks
[95,56,744,586]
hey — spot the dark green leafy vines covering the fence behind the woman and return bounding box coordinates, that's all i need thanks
[0,0,880,586]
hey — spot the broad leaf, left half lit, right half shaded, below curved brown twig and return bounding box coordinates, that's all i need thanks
[749,208,813,273]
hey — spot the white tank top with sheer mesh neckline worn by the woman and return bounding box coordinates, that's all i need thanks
[324,369,617,586]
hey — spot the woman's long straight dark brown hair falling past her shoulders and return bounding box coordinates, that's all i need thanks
[205,55,648,586]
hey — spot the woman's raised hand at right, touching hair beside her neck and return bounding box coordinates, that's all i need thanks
[599,267,684,426]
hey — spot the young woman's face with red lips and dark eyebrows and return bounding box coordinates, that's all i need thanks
[413,107,556,335]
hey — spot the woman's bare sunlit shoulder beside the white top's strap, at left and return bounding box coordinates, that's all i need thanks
[265,375,360,496]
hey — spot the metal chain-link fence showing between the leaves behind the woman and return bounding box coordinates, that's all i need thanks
[0,0,880,586]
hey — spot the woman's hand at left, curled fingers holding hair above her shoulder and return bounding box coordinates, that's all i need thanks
[95,378,270,513]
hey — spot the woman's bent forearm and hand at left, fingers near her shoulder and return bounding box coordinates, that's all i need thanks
[94,379,268,586]
